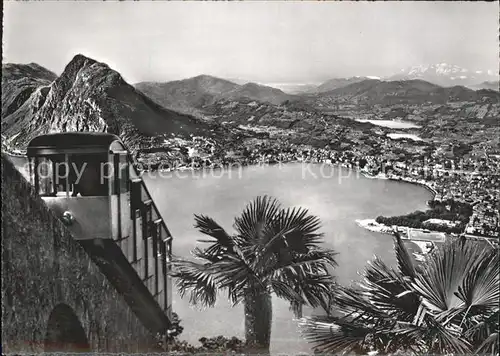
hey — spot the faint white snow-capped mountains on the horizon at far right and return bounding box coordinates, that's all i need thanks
[385,63,499,88]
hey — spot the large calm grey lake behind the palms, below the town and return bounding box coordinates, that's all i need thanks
[144,163,432,354]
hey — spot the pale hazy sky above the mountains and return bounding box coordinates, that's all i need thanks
[2,1,499,83]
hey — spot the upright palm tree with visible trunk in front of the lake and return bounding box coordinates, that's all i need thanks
[172,196,336,351]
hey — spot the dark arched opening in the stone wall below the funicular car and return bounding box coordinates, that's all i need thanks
[44,303,90,353]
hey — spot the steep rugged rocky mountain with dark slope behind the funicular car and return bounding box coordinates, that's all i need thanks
[2,55,217,148]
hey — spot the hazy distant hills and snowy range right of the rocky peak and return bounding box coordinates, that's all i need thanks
[136,64,498,113]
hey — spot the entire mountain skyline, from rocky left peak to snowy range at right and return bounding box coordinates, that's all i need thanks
[2,55,500,153]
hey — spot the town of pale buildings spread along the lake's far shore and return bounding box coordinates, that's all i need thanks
[133,107,500,237]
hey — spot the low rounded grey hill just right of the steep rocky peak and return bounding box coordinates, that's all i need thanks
[135,75,293,113]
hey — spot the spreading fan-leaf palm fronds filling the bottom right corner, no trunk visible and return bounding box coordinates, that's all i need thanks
[301,235,499,354]
